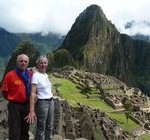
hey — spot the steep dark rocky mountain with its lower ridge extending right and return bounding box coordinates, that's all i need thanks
[54,5,150,93]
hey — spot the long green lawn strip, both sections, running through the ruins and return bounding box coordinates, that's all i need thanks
[51,77,140,133]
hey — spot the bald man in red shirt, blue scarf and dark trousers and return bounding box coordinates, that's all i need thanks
[1,54,31,140]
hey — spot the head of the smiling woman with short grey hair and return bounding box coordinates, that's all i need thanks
[37,58,48,73]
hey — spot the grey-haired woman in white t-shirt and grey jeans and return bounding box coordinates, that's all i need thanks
[26,56,54,140]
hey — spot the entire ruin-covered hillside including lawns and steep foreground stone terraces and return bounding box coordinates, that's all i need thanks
[0,70,150,140]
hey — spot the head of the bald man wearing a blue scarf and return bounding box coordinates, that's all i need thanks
[17,54,29,71]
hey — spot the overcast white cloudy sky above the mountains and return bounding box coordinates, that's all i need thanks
[0,0,150,35]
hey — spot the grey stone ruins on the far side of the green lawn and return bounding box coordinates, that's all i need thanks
[54,70,150,136]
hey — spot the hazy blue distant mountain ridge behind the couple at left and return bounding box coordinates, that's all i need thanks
[0,28,64,79]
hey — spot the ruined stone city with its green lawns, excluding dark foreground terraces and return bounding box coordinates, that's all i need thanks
[51,70,149,139]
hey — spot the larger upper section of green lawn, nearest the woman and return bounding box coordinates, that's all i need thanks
[51,77,113,111]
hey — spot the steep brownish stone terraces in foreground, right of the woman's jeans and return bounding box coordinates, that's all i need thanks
[54,98,132,140]
